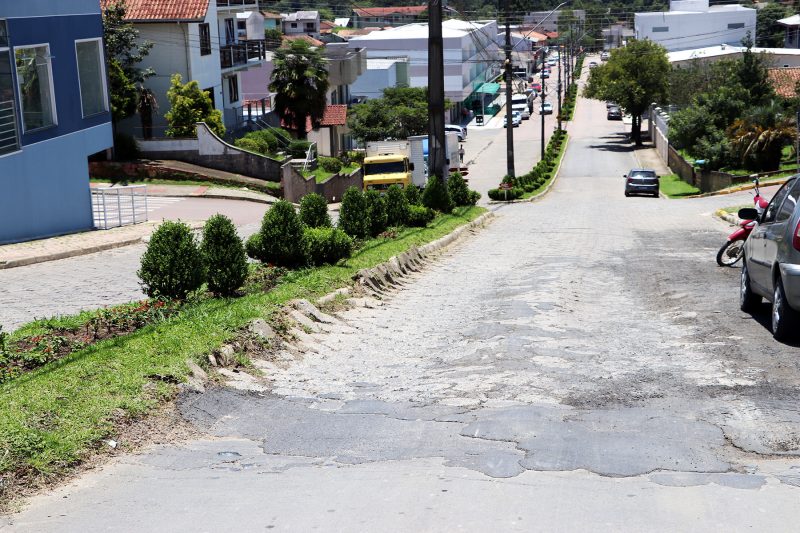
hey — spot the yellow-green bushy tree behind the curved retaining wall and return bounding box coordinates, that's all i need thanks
[164,74,225,137]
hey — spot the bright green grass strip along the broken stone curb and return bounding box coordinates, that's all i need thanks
[0,207,485,507]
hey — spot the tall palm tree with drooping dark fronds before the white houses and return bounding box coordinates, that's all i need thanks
[269,40,328,139]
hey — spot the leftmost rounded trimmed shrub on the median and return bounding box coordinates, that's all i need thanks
[136,221,206,299]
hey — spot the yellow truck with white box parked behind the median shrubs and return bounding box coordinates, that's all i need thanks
[362,141,414,191]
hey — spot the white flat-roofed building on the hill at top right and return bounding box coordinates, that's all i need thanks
[634,0,756,52]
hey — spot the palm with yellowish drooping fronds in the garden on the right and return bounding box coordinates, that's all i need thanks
[728,102,797,171]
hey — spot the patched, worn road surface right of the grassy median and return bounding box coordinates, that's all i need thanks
[6,101,800,532]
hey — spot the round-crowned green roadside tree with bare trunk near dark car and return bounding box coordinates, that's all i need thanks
[584,40,670,146]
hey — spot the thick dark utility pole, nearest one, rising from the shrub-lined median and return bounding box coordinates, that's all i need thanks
[428,0,449,181]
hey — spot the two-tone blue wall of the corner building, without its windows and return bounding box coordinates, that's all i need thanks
[0,0,113,244]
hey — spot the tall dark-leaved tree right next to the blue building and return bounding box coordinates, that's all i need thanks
[103,0,155,122]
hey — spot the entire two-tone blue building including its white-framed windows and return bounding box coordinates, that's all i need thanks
[0,0,113,244]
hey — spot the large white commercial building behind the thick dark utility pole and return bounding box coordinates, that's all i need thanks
[348,19,501,119]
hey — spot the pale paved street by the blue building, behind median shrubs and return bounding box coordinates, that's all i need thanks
[0,197,268,331]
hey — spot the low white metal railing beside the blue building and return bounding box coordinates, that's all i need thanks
[92,185,147,229]
